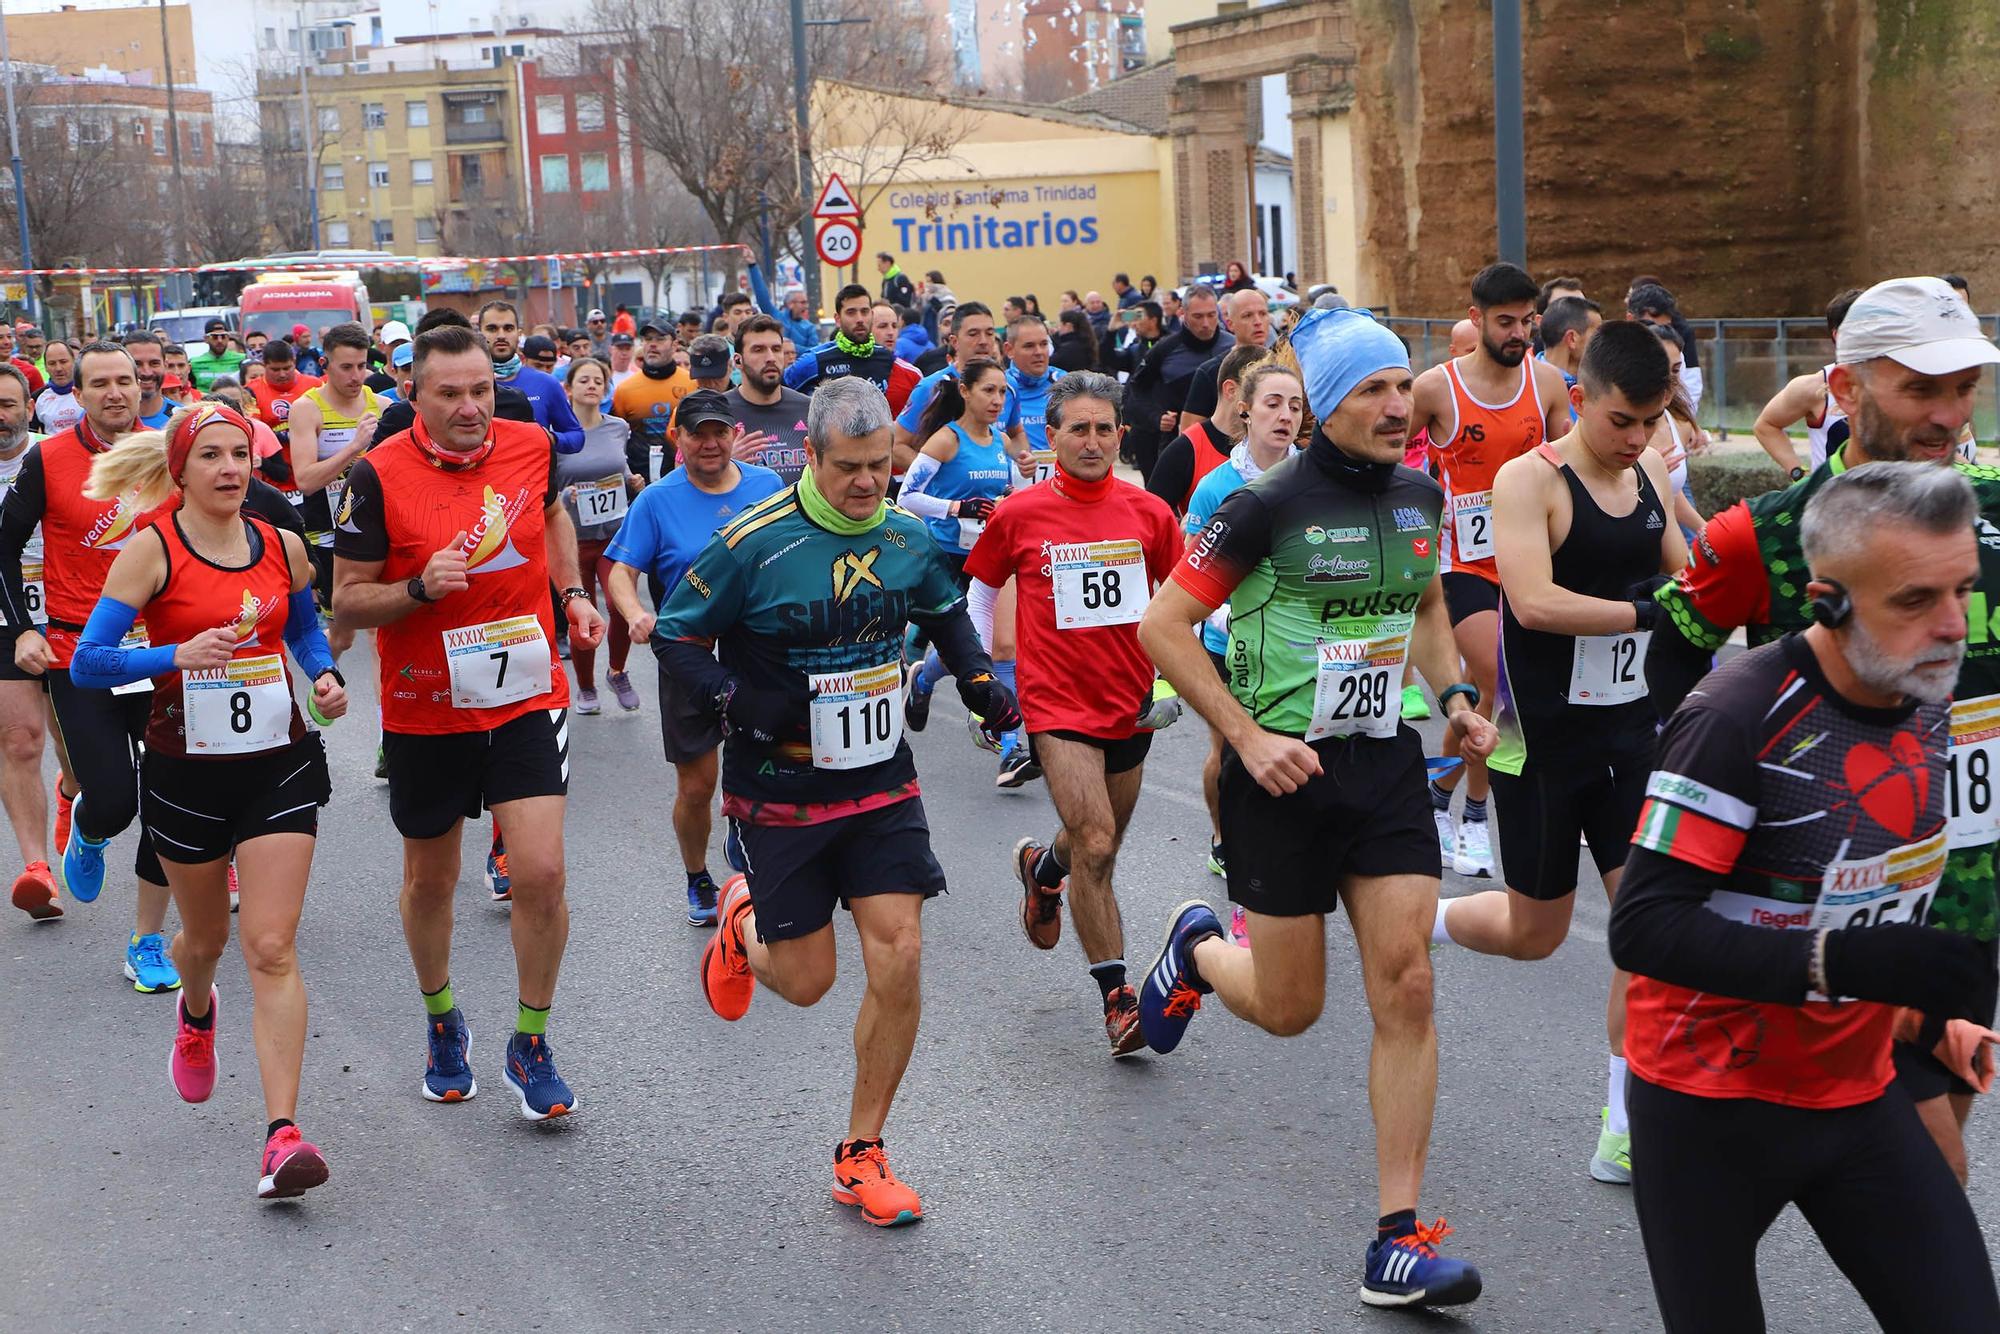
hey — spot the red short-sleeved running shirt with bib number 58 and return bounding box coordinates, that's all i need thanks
[966,472,1184,740]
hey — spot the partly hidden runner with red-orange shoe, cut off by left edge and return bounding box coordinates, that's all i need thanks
[0,370,55,922]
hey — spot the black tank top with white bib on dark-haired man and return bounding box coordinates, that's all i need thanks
[1494,444,1670,772]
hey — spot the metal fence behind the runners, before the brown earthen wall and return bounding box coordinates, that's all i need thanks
[1386,316,2000,442]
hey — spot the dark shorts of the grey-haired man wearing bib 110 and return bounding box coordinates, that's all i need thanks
[736,796,944,940]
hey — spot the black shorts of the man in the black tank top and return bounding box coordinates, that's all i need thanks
[1486,746,1652,902]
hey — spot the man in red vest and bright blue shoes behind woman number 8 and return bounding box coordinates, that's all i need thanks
[0,342,180,994]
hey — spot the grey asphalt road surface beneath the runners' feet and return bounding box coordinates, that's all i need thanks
[0,648,2000,1334]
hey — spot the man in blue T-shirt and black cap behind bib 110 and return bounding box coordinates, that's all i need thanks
[604,392,784,926]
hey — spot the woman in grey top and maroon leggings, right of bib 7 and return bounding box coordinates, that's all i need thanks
[556,356,646,716]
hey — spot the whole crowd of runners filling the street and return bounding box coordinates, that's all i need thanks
[0,256,2000,1332]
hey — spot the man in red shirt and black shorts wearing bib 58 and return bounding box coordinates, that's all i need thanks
[966,372,1182,1056]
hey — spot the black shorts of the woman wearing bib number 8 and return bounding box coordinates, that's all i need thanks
[138,732,334,864]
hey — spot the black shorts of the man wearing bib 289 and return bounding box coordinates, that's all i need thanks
[1218,724,1440,918]
